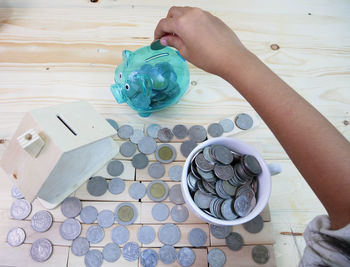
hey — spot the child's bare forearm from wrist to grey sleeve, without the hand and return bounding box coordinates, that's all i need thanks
[224,51,350,229]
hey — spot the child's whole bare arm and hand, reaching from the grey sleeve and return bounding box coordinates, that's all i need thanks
[154,7,350,229]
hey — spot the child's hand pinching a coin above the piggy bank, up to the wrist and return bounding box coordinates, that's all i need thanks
[154,7,247,76]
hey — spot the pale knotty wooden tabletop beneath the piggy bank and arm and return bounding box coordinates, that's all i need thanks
[0,0,350,267]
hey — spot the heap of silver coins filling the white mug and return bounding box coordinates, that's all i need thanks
[187,145,262,220]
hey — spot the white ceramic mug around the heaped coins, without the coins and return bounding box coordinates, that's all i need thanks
[181,137,280,225]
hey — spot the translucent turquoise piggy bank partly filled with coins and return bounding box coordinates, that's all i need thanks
[111,46,190,117]
